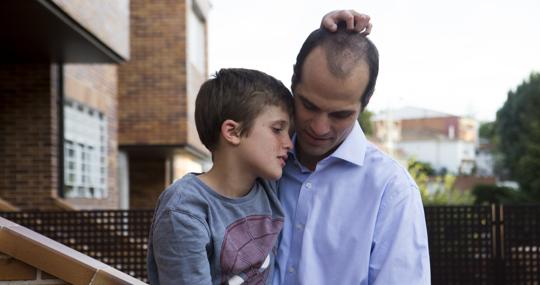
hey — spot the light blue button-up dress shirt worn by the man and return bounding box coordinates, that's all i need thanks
[273,124,430,285]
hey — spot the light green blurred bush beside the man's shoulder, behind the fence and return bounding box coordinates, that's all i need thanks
[407,159,474,205]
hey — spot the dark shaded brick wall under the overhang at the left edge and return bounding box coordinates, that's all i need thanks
[0,64,58,209]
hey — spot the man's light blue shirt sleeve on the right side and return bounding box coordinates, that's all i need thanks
[369,172,431,285]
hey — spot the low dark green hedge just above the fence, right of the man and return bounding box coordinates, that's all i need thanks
[472,184,533,205]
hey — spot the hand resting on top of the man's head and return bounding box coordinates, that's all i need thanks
[321,10,372,36]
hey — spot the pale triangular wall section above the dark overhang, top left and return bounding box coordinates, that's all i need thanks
[51,0,129,58]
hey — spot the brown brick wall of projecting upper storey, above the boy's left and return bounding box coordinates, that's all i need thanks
[119,0,187,145]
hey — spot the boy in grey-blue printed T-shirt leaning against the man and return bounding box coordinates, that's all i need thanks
[148,69,293,285]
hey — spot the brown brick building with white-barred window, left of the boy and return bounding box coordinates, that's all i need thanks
[0,0,209,210]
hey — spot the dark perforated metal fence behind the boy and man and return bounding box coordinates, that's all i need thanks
[0,205,540,285]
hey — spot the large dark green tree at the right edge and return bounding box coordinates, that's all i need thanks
[495,73,540,200]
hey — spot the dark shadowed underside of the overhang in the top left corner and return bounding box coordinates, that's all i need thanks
[0,0,126,63]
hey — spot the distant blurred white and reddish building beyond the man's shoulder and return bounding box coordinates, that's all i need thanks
[373,107,478,174]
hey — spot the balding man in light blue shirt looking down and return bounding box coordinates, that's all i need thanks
[274,11,430,285]
